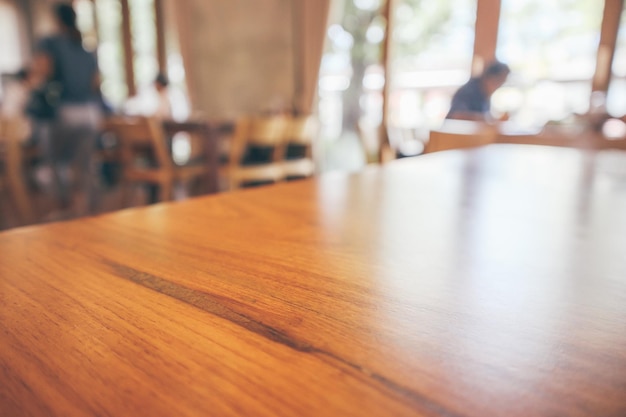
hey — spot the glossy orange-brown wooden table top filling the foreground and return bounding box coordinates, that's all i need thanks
[0,145,626,417]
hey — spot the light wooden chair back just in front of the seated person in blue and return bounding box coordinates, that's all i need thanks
[424,120,498,153]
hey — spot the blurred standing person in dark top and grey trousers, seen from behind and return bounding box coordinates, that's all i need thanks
[33,3,102,214]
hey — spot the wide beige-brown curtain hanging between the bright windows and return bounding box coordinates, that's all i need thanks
[175,0,329,120]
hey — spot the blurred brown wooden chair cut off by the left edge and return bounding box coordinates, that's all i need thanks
[0,118,35,224]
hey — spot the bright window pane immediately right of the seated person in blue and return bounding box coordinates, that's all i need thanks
[493,0,603,126]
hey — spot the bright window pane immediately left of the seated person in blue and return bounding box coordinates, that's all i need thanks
[389,0,476,131]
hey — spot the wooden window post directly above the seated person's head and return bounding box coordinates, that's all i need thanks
[472,0,501,76]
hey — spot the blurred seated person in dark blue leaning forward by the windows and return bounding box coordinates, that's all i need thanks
[446,61,511,123]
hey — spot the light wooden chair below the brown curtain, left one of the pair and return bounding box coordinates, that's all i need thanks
[223,116,288,190]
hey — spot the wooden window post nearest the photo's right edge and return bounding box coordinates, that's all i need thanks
[591,0,624,92]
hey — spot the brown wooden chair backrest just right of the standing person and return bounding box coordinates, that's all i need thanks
[108,116,174,169]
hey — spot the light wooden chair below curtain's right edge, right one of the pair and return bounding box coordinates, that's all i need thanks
[282,115,317,179]
